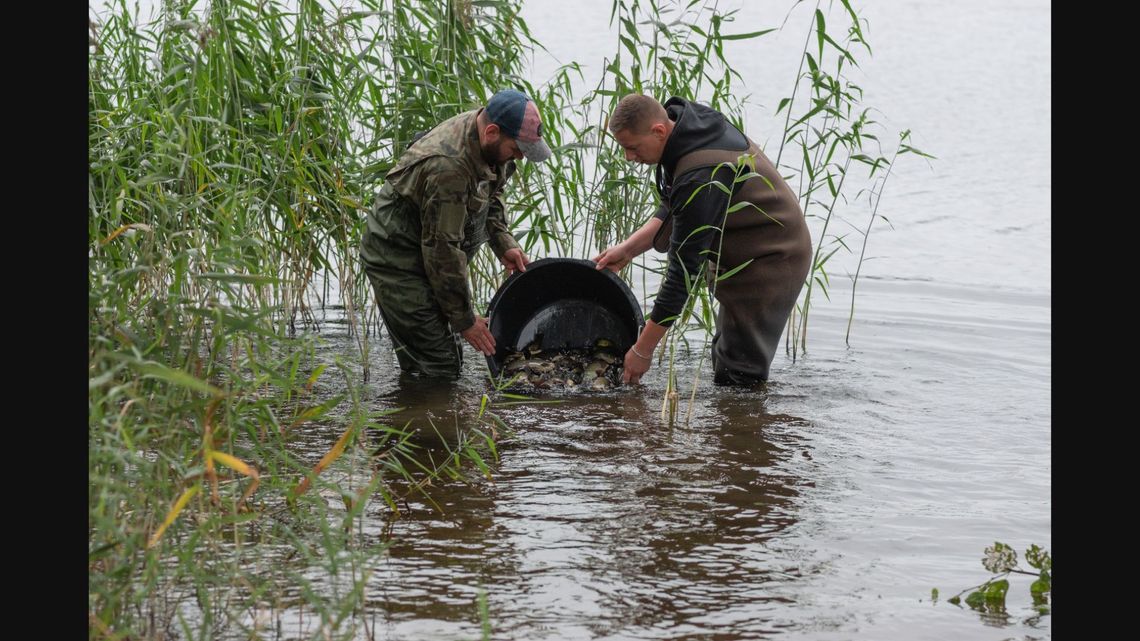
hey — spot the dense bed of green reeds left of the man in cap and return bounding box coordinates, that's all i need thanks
[88,0,524,639]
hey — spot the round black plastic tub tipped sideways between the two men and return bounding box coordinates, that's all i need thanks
[487,258,644,376]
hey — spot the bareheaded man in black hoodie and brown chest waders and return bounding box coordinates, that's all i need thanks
[594,94,812,384]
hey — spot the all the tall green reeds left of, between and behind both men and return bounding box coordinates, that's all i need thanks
[88,0,926,639]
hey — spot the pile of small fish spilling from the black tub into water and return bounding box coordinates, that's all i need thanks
[503,339,624,390]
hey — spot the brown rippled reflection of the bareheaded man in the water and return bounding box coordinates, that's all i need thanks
[579,392,803,638]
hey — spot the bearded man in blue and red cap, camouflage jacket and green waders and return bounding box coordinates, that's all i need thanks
[360,89,551,378]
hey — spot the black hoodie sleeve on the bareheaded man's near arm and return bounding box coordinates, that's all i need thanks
[649,167,732,326]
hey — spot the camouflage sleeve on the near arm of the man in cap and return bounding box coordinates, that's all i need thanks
[420,165,475,332]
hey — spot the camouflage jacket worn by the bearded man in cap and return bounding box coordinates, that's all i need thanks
[360,109,519,332]
